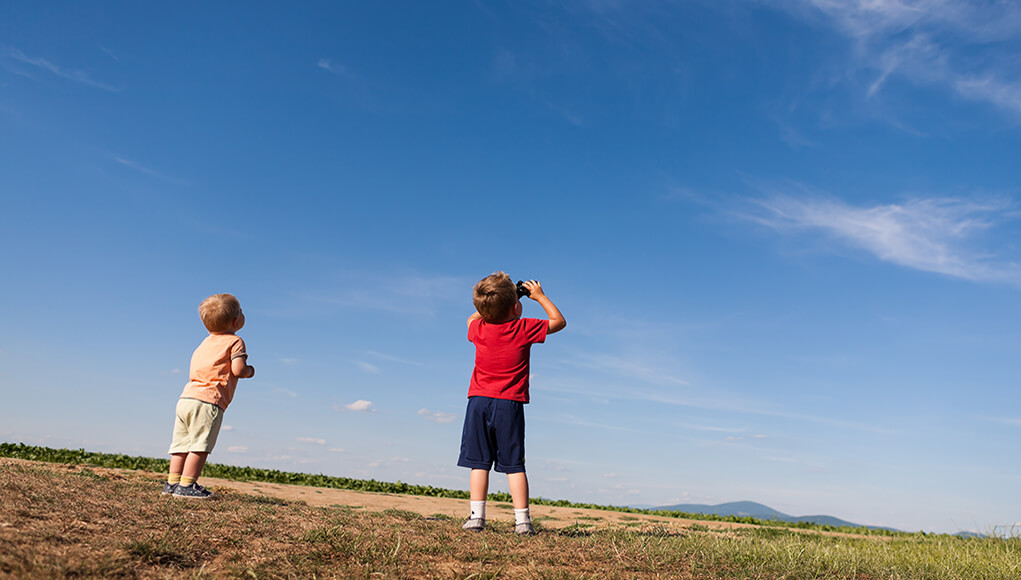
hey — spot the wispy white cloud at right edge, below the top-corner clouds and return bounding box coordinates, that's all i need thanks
[738,194,1021,285]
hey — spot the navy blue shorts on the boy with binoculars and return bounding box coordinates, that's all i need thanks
[457,397,525,473]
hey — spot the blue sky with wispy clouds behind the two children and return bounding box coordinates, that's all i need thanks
[0,0,1021,531]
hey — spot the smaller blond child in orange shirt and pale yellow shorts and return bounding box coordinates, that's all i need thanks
[163,294,255,499]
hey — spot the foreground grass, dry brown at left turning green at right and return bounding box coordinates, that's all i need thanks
[0,447,1021,580]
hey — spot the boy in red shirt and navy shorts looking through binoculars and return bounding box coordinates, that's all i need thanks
[457,272,568,535]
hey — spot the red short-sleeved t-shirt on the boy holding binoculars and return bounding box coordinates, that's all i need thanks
[468,319,549,402]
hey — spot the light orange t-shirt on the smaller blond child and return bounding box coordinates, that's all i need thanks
[181,334,248,410]
